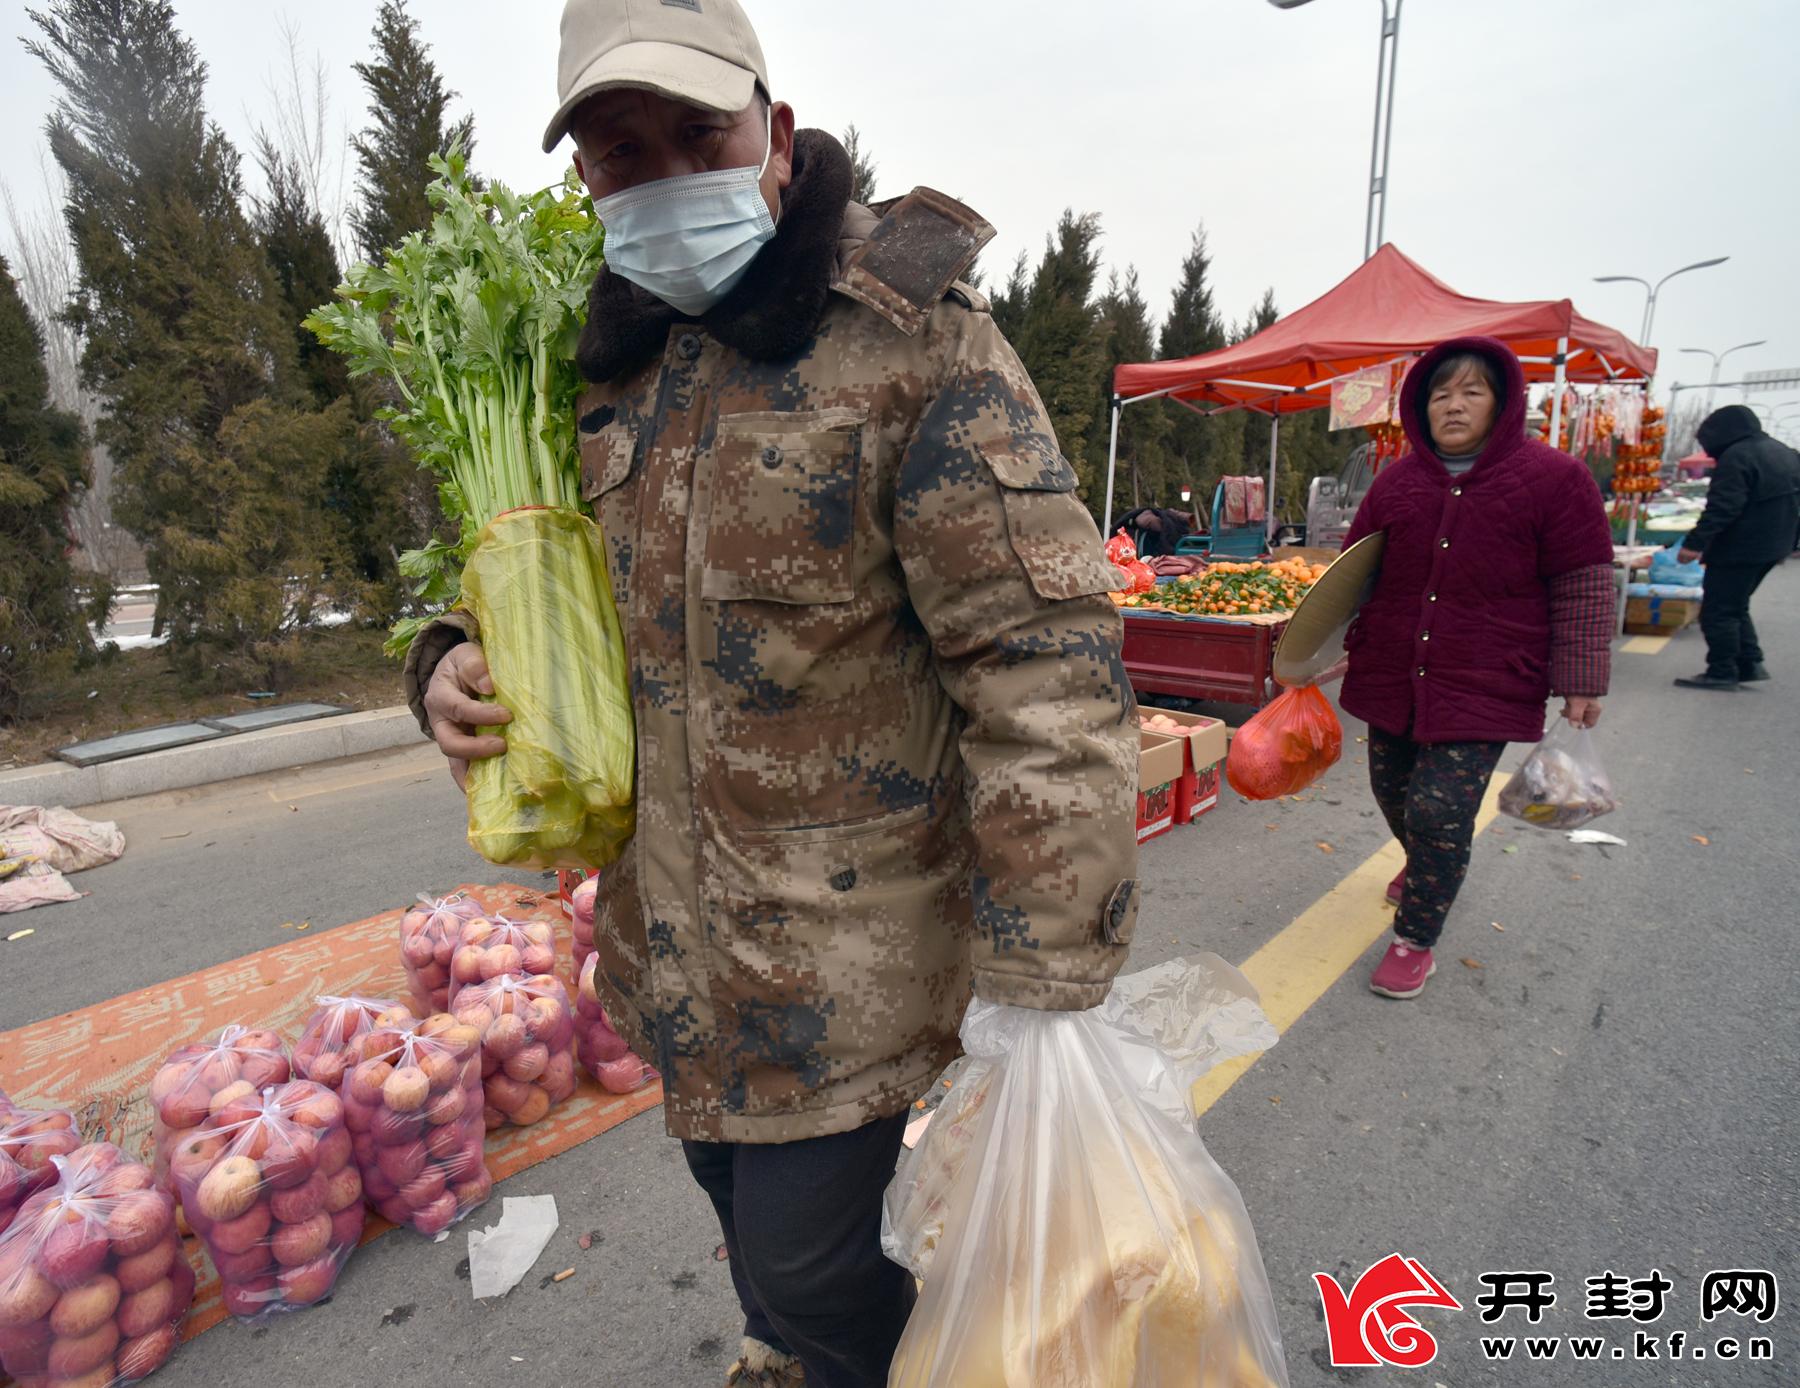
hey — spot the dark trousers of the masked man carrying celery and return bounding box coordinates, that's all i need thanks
[682,1113,918,1388]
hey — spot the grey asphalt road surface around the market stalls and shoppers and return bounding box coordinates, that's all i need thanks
[0,567,1800,1388]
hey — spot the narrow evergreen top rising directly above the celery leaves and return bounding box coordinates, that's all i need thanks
[351,0,475,262]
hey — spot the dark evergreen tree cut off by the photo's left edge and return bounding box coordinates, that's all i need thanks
[0,259,92,724]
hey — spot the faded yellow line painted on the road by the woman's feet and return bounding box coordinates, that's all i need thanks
[1193,776,1507,1114]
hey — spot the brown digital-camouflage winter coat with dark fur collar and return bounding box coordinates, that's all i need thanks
[409,131,1138,1143]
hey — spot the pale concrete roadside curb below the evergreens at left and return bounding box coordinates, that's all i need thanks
[0,708,423,808]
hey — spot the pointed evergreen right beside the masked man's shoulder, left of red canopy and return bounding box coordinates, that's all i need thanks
[1006,211,1105,509]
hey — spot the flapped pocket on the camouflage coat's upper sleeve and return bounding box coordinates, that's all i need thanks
[981,434,1120,601]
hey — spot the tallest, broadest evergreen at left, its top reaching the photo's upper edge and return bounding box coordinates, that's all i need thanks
[27,0,360,671]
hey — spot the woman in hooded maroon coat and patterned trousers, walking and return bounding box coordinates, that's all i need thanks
[1343,337,1615,997]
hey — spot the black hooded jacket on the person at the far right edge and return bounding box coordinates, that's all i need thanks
[1687,405,1800,563]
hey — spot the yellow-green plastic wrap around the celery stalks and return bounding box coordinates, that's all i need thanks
[463,506,637,868]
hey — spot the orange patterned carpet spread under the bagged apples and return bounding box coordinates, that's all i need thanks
[0,886,662,1346]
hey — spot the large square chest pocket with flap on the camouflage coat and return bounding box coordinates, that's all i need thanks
[700,409,868,603]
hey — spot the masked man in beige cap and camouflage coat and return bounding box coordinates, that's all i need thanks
[407,0,1138,1388]
